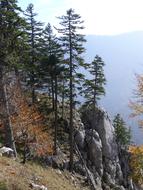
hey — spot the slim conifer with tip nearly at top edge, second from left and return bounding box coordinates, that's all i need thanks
[25,4,43,103]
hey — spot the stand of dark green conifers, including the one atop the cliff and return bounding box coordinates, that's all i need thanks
[1,1,106,165]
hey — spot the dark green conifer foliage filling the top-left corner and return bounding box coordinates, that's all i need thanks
[0,0,25,68]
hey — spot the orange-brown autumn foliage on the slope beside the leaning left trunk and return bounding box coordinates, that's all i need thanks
[1,78,53,156]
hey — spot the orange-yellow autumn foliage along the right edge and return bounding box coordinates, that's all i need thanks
[129,75,143,184]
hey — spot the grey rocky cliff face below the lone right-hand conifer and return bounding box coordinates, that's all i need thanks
[75,108,136,190]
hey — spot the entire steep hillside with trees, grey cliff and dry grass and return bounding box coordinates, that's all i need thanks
[0,0,143,190]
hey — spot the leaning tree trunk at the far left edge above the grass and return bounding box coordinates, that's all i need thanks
[0,67,17,157]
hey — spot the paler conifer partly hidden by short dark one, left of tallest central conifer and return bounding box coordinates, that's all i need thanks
[41,23,64,111]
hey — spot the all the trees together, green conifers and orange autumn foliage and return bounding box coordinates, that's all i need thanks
[0,0,143,189]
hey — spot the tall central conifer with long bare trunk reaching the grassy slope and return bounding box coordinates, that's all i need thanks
[58,9,85,171]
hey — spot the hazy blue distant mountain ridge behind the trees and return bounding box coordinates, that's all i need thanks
[85,31,143,144]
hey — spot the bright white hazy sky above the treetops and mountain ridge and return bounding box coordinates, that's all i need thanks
[19,0,143,35]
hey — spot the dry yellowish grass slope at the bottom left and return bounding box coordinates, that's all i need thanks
[0,157,88,190]
